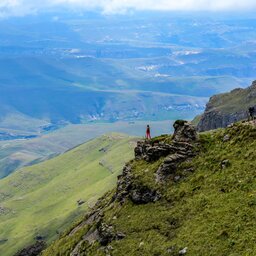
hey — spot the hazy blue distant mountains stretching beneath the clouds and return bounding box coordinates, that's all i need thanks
[0,10,256,130]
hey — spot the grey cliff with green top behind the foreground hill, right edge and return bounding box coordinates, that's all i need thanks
[197,81,256,131]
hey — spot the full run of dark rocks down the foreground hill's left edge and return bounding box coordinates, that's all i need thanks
[49,120,198,256]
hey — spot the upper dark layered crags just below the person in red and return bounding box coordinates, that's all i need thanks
[115,120,198,201]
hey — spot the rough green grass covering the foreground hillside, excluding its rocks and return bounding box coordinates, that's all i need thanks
[43,124,256,256]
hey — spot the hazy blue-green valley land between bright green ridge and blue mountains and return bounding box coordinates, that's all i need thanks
[0,119,172,178]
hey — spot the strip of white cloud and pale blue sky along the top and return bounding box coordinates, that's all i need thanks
[0,0,256,17]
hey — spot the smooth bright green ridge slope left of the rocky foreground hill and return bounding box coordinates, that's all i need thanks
[0,134,134,256]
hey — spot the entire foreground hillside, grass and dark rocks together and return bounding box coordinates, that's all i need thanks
[43,121,256,256]
